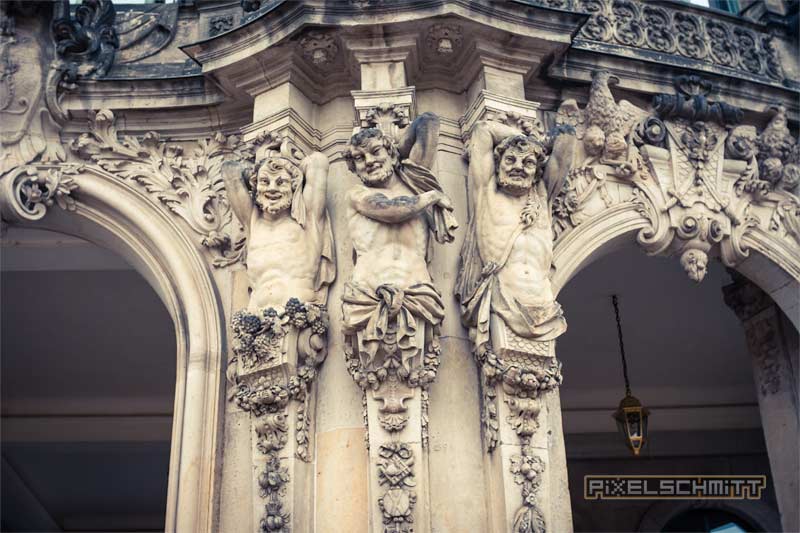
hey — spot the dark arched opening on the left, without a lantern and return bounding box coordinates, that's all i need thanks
[0,227,176,531]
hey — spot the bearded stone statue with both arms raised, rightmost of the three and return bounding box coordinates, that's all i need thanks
[456,121,576,358]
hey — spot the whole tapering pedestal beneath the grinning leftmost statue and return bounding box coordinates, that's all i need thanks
[229,299,328,533]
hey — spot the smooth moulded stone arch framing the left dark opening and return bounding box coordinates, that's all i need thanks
[0,165,224,531]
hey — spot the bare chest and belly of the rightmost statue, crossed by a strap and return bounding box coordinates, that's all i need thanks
[475,179,554,305]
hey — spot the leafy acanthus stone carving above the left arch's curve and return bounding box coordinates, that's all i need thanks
[70,110,247,267]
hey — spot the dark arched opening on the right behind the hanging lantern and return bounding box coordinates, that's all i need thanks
[558,241,780,531]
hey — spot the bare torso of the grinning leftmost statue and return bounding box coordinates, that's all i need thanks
[247,209,323,311]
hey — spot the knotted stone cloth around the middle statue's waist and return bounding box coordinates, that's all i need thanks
[342,282,444,369]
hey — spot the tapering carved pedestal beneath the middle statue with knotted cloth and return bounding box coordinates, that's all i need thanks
[345,317,441,533]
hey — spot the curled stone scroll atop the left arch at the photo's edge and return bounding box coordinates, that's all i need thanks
[0,165,81,221]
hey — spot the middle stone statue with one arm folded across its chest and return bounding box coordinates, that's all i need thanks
[343,113,457,420]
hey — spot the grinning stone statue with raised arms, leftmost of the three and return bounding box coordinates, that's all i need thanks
[223,137,336,312]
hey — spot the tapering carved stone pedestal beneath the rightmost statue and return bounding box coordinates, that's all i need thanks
[477,328,572,533]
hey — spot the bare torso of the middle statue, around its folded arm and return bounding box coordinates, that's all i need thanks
[347,182,431,289]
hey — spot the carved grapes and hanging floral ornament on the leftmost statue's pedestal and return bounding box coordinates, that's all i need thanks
[228,298,328,533]
